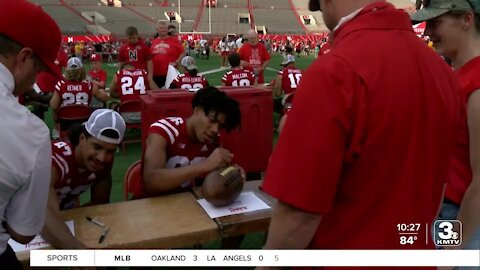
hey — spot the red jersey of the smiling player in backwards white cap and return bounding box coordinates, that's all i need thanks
[52,140,113,210]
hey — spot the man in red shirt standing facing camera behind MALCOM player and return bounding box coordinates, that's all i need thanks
[238,29,270,83]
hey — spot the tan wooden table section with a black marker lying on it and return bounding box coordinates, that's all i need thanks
[17,192,220,260]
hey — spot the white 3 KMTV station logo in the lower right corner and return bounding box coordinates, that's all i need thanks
[433,220,462,247]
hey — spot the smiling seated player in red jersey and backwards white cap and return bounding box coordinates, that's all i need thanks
[42,109,125,249]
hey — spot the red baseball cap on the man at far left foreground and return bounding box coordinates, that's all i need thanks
[0,0,62,76]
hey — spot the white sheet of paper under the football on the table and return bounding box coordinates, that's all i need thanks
[197,191,270,218]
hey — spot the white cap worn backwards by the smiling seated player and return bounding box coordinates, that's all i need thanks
[85,109,126,144]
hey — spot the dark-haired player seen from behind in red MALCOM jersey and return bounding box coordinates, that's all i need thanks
[222,53,256,87]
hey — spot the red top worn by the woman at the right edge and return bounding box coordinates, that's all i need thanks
[445,57,480,205]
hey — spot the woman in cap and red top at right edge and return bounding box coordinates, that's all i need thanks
[411,0,480,252]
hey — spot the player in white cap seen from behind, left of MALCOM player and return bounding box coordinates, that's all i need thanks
[170,56,208,90]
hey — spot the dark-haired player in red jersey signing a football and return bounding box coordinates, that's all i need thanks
[134,87,241,198]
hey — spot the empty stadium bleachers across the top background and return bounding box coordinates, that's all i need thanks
[31,0,412,36]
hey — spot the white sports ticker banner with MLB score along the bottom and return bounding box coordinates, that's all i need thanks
[30,249,480,267]
